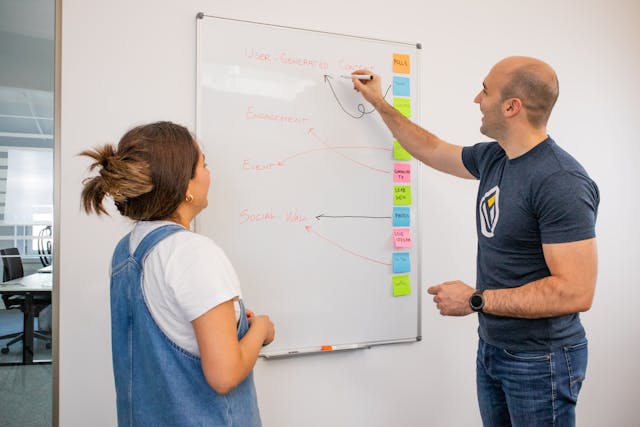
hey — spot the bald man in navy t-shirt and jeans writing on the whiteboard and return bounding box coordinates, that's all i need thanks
[353,57,600,426]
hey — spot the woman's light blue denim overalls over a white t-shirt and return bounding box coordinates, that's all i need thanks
[111,225,261,427]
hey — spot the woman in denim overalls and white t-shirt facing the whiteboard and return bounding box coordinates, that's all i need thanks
[80,122,274,426]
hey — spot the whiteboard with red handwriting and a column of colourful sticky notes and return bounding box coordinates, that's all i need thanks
[196,14,421,358]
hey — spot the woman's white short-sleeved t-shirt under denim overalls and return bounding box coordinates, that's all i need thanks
[130,221,242,355]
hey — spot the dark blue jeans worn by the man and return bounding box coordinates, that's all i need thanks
[476,339,588,427]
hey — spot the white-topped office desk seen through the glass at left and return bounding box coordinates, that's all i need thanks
[0,273,53,365]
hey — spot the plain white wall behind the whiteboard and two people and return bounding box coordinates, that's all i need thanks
[58,0,640,427]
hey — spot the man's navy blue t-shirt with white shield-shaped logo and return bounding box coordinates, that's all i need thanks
[462,138,600,351]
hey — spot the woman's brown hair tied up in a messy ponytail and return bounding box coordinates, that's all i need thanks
[80,122,199,221]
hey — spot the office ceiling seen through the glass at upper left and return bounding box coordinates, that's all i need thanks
[0,0,55,149]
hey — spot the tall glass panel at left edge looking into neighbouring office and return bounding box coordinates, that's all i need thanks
[0,0,55,426]
